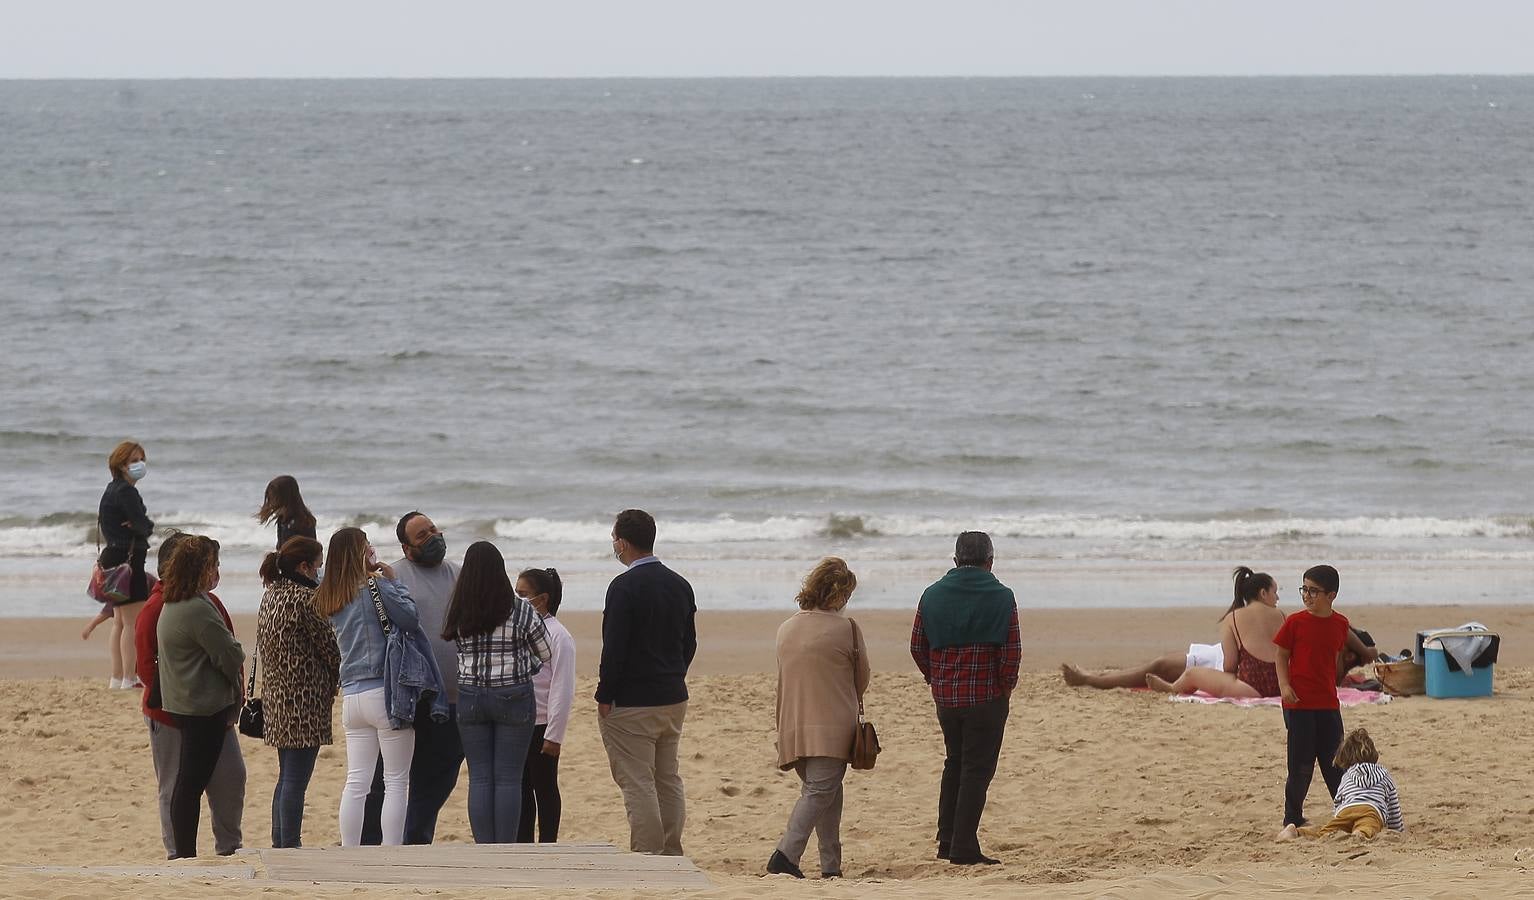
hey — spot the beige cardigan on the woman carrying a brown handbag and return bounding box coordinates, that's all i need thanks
[778,609,870,768]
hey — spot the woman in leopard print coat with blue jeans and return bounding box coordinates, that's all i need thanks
[256,537,341,846]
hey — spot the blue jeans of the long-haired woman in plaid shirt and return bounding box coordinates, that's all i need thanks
[459,682,537,843]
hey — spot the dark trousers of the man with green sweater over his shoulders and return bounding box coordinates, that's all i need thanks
[937,698,1008,859]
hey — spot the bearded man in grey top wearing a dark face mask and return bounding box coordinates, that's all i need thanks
[362,509,463,845]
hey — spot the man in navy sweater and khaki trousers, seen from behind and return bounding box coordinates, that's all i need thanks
[597,509,698,856]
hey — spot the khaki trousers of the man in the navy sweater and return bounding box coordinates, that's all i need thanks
[598,701,687,856]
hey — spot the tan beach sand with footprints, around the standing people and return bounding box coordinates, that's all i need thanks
[0,607,1534,900]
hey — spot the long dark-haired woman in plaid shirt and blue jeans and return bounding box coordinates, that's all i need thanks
[442,541,552,843]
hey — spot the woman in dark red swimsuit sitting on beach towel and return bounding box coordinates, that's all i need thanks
[1146,566,1284,698]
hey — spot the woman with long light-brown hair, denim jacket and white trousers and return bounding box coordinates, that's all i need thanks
[314,527,420,846]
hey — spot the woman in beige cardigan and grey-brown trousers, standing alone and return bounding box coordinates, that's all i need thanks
[767,557,868,879]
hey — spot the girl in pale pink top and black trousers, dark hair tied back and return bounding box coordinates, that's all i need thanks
[517,569,575,843]
